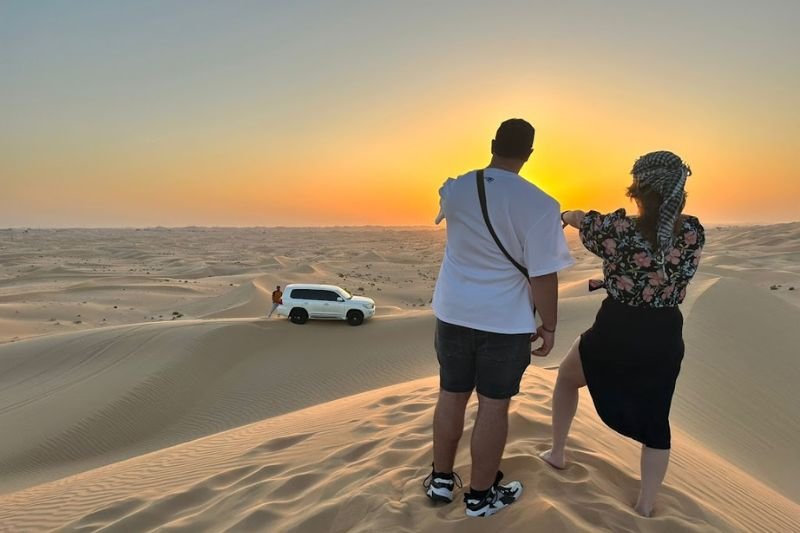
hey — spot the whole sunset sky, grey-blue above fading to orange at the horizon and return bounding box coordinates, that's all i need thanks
[0,0,800,227]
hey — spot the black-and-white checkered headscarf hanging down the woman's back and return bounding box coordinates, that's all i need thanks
[631,151,692,253]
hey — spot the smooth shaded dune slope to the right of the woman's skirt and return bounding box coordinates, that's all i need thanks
[672,279,800,502]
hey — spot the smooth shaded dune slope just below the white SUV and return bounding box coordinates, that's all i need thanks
[0,315,437,490]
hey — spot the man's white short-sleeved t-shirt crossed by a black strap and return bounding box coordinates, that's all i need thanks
[433,168,573,333]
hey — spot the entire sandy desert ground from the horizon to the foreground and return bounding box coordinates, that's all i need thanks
[0,223,800,532]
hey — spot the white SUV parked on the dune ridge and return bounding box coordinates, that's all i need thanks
[276,284,375,326]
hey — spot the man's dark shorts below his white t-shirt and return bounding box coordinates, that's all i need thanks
[434,319,531,400]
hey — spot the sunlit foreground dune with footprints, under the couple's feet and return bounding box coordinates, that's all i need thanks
[0,370,800,532]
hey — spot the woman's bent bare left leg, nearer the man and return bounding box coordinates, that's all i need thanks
[539,339,586,469]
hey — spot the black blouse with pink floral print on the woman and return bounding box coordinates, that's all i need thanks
[580,209,705,307]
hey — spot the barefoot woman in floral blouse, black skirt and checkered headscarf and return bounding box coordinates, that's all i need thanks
[541,151,705,516]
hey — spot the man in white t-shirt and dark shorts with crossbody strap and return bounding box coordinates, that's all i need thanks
[424,119,573,516]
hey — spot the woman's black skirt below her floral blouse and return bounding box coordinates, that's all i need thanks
[580,297,684,450]
